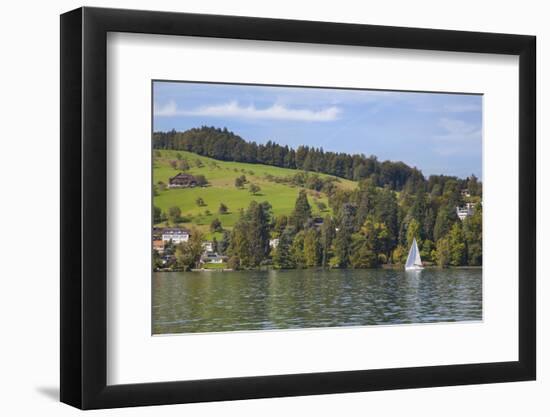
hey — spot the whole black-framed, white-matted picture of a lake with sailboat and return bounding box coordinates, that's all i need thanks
[61,7,536,409]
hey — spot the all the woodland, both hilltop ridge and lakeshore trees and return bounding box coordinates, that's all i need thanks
[153,127,482,269]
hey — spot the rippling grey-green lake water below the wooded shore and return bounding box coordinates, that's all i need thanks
[153,269,482,334]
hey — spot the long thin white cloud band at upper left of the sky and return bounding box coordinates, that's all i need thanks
[154,101,342,122]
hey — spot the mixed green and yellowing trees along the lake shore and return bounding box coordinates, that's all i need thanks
[172,179,482,269]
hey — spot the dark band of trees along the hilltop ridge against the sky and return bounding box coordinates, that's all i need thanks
[153,126,481,195]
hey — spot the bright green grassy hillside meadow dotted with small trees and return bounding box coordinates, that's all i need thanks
[153,150,356,238]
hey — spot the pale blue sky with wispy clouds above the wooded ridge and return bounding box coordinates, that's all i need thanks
[153,81,482,178]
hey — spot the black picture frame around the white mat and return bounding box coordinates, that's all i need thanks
[60,7,536,409]
